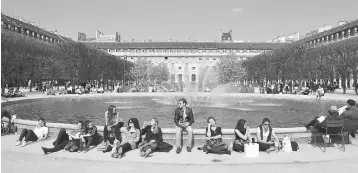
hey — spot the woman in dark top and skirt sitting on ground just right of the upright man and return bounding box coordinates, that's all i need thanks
[205,117,231,155]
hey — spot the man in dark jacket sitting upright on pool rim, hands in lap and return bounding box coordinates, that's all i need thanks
[174,98,194,154]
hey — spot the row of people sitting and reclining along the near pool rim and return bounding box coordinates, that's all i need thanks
[12,98,296,158]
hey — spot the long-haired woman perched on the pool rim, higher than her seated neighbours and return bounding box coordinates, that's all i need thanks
[100,105,124,152]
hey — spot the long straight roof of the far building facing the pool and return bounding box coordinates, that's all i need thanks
[83,42,288,50]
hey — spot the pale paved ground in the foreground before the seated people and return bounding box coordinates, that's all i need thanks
[1,135,358,173]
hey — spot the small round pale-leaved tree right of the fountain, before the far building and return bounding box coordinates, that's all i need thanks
[216,55,247,84]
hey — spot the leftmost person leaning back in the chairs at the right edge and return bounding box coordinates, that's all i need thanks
[306,106,342,133]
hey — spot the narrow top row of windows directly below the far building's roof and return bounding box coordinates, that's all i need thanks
[105,49,269,53]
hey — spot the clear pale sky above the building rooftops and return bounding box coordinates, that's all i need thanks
[1,0,358,42]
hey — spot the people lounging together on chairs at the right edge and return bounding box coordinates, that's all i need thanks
[306,99,358,137]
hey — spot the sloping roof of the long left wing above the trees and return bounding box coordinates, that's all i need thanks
[1,14,73,42]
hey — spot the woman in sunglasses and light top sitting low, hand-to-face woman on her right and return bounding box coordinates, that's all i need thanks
[112,118,141,158]
